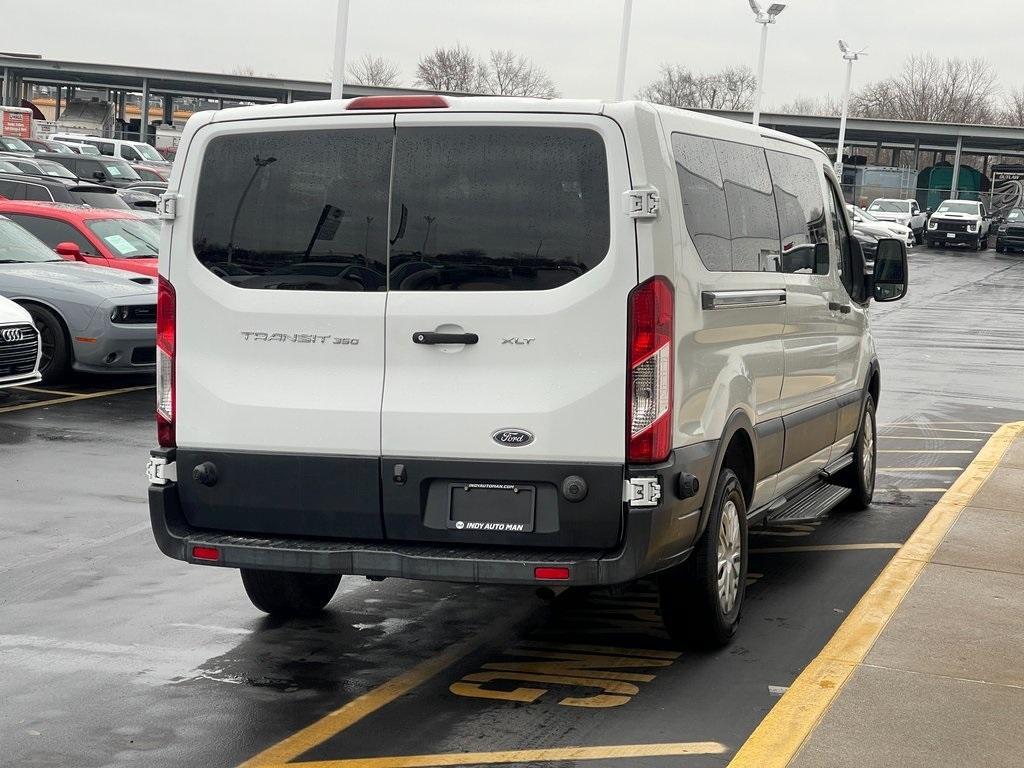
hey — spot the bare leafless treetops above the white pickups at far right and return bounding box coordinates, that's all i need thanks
[851,54,999,123]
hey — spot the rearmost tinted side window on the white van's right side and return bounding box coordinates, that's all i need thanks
[672,133,732,272]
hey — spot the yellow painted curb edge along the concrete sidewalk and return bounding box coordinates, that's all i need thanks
[729,422,1024,768]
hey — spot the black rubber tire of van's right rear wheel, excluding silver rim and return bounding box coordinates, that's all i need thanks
[657,468,748,650]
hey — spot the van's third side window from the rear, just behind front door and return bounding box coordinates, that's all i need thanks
[767,150,828,274]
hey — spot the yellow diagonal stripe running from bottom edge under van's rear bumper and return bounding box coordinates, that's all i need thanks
[239,604,538,768]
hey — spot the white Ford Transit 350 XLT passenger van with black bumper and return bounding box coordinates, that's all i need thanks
[147,95,906,645]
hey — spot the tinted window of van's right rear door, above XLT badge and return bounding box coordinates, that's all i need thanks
[390,127,609,291]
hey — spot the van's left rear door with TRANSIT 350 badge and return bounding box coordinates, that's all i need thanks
[168,115,394,539]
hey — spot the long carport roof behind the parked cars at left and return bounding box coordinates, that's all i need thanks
[0,55,436,101]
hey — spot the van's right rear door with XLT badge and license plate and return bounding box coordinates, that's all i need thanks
[381,113,637,547]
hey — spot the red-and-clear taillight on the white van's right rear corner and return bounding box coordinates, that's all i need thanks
[626,275,674,464]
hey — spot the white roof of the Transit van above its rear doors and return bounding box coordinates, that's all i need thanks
[201,94,823,154]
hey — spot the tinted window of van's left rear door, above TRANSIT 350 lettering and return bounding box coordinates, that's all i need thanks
[193,128,393,291]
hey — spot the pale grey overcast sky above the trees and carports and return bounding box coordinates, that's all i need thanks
[8,0,1024,108]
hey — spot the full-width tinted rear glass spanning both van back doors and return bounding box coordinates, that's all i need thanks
[194,127,609,291]
